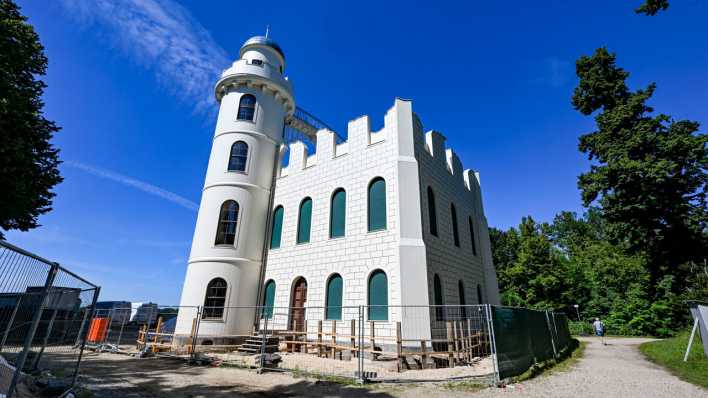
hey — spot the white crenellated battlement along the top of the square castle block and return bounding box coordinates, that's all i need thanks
[279,98,480,199]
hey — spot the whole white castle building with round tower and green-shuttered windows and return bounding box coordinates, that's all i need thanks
[176,36,499,344]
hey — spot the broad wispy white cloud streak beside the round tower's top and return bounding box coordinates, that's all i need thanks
[62,0,230,112]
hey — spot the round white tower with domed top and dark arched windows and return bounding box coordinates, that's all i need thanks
[175,36,295,338]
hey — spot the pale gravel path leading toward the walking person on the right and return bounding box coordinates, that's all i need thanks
[479,338,708,398]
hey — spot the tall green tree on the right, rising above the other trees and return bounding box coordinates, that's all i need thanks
[572,48,708,288]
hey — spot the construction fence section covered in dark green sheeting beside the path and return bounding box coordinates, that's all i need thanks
[491,306,571,379]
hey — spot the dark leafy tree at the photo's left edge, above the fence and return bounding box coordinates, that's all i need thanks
[0,0,62,238]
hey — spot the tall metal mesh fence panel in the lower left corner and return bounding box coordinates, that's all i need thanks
[0,241,99,397]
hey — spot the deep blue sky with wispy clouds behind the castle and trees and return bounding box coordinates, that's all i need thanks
[7,0,708,304]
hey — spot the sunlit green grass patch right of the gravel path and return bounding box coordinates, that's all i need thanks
[639,331,708,388]
